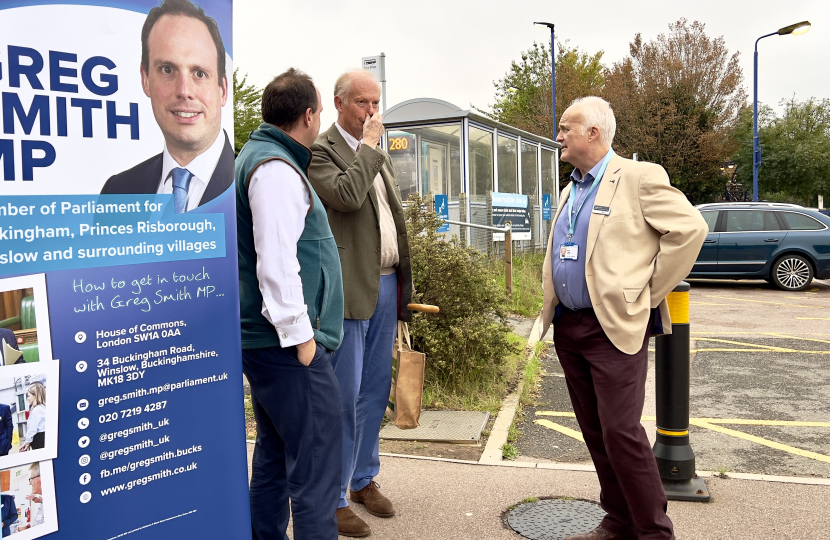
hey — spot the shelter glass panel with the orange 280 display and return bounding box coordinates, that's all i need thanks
[387,123,461,201]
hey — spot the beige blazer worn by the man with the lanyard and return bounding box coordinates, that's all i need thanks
[542,155,708,354]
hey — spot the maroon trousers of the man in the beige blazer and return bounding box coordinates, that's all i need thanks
[553,309,673,540]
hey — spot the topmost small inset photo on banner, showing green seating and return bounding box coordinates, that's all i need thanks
[0,274,52,366]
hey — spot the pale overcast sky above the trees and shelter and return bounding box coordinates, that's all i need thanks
[233,0,830,130]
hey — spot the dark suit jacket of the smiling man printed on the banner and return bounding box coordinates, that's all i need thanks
[101,130,235,206]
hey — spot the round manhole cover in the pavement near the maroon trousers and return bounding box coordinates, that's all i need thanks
[507,499,605,540]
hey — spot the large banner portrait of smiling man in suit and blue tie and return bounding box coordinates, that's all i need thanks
[101,0,234,214]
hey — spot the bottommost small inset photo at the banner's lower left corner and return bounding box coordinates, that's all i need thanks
[0,461,58,540]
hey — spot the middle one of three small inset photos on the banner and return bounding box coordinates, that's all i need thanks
[0,361,59,468]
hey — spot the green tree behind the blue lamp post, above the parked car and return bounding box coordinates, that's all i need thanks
[734,98,830,205]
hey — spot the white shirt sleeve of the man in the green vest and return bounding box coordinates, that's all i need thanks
[248,160,314,348]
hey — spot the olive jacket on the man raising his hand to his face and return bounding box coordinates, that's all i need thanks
[308,124,412,322]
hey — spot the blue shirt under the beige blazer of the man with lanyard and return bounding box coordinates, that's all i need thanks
[551,149,614,310]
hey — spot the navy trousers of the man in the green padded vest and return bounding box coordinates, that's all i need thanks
[242,344,343,540]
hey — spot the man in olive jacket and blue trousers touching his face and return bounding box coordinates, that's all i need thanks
[308,70,412,536]
